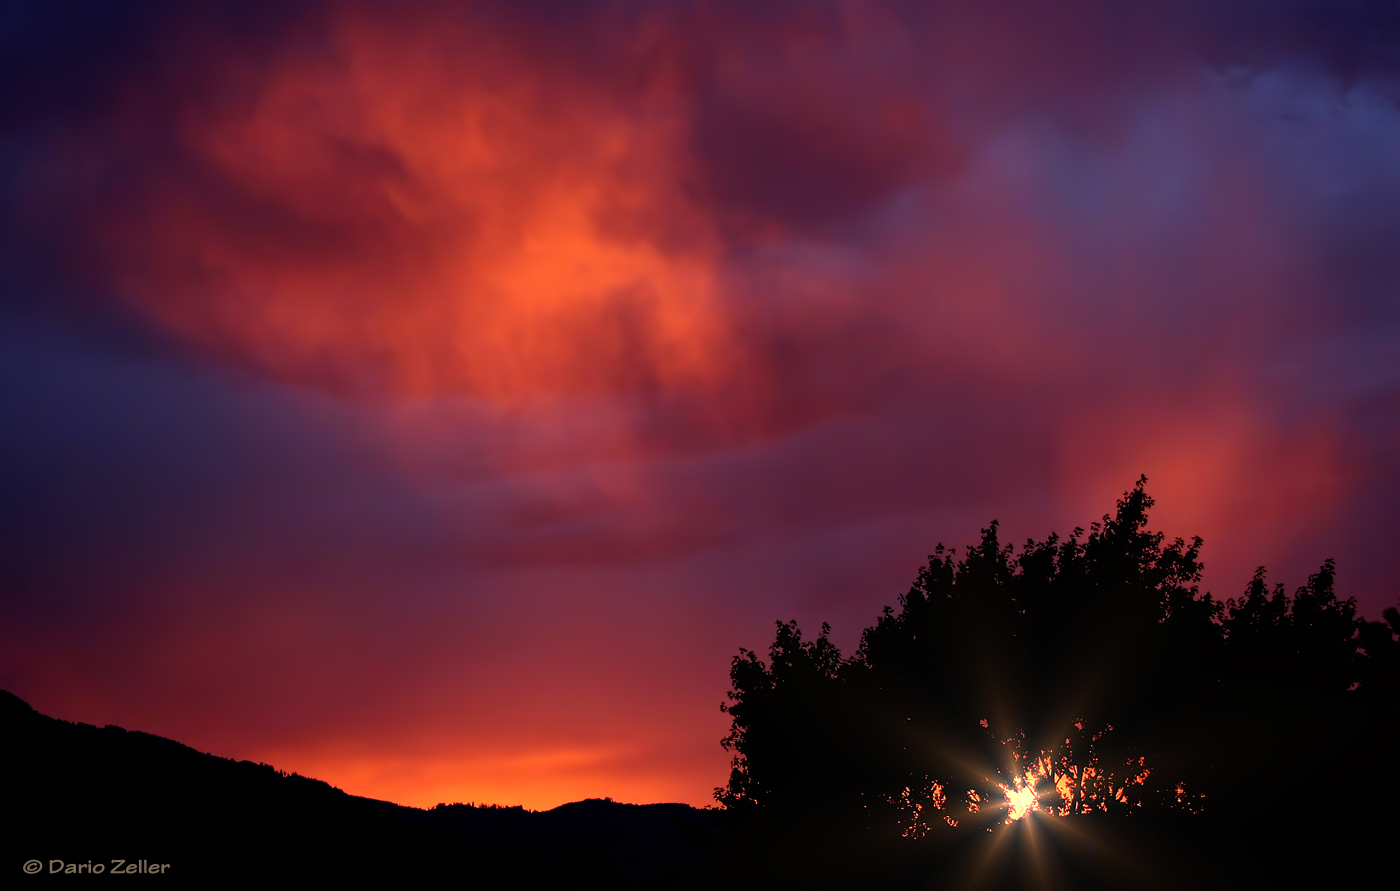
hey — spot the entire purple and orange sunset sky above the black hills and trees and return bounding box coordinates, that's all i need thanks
[0,0,1400,808]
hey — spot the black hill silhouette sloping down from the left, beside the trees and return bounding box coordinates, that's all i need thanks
[0,692,720,888]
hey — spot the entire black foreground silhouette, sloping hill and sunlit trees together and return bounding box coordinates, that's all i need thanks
[10,479,1400,891]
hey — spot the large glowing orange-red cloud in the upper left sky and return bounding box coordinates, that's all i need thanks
[91,6,734,402]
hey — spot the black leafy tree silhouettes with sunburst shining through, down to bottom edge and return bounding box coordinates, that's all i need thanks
[715,478,1400,888]
